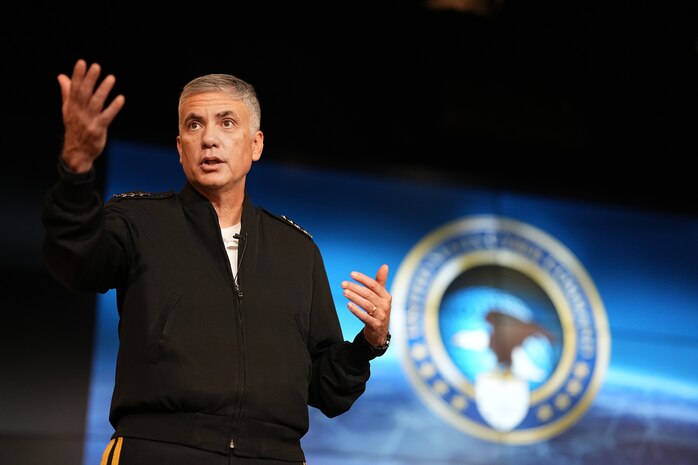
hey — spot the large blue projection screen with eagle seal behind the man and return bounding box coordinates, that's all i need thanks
[83,142,698,465]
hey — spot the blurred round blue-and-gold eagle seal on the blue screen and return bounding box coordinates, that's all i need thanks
[392,215,610,444]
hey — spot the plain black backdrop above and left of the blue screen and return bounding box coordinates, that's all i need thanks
[0,1,698,465]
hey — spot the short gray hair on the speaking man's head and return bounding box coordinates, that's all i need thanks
[177,74,262,135]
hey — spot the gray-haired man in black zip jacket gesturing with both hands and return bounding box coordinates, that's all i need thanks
[42,59,392,465]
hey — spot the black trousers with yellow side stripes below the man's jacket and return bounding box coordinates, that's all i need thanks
[100,437,306,465]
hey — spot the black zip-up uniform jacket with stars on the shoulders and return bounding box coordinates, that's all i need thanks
[42,164,374,461]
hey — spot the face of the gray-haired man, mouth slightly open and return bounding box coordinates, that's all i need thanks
[177,92,264,197]
